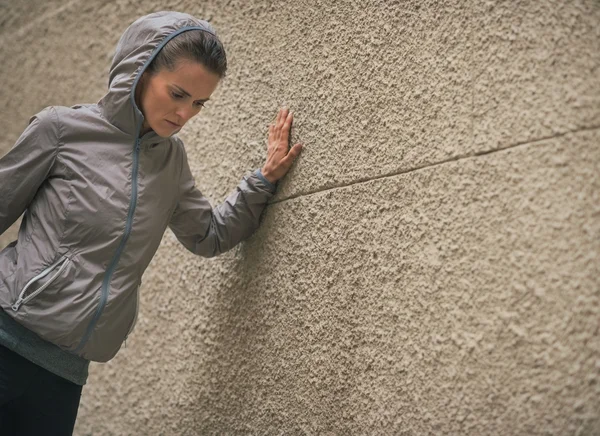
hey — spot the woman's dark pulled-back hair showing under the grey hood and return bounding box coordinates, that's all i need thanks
[146,30,227,78]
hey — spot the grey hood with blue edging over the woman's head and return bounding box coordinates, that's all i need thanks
[98,11,215,138]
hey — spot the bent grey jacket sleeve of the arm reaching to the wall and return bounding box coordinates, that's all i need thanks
[169,146,277,257]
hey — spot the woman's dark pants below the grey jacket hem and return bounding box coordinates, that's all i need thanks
[0,345,83,436]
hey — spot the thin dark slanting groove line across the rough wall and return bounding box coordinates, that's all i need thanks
[267,125,600,206]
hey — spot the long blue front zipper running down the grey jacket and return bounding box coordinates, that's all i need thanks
[74,136,141,353]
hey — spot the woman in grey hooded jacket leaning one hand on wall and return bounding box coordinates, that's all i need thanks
[0,11,302,435]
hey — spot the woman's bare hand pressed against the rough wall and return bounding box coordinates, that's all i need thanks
[260,109,302,183]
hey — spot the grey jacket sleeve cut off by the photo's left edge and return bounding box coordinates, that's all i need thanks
[0,106,59,235]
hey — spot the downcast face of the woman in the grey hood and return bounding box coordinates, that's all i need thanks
[136,60,220,137]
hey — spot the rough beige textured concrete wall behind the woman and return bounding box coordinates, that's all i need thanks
[0,0,600,435]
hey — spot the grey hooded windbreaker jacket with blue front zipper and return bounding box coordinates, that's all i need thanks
[0,11,275,362]
